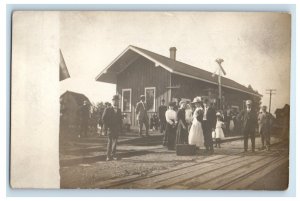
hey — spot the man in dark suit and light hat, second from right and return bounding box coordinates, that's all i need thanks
[238,100,257,152]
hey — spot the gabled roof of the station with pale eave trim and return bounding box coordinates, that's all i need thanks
[96,46,261,96]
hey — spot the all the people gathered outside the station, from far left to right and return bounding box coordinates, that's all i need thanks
[73,95,272,161]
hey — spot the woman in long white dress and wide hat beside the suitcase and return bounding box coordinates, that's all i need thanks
[189,96,204,149]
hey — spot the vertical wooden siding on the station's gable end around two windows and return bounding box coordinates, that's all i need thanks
[117,57,170,126]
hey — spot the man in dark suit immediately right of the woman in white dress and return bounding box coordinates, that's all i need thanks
[202,99,217,153]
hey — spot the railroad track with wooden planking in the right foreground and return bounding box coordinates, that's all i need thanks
[92,139,288,189]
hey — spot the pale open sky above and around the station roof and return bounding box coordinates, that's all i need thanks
[59,11,291,112]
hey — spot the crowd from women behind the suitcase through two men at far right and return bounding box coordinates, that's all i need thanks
[159,97,272,153]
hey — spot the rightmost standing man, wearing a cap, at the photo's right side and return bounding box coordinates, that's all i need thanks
[258,105,272,151]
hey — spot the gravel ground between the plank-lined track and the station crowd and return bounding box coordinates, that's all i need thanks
[60,135,279,188]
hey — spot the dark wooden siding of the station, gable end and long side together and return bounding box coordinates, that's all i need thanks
[117,56,251,126]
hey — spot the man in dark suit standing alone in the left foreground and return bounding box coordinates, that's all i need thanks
[102,95,122,161]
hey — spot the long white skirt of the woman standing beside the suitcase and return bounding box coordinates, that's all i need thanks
[189,119,204,148]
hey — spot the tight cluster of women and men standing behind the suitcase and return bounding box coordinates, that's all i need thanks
[160,97,218,153]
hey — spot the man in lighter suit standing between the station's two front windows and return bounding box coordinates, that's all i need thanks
[136,95,149,136]
